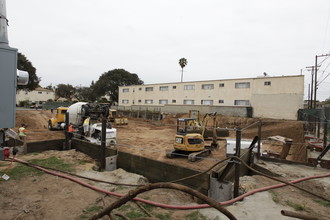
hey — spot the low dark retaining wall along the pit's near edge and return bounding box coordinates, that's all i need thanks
[28,138,253,198]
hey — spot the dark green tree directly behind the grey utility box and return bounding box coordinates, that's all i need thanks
[17,53,41,90]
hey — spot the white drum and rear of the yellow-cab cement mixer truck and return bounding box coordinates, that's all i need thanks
[67,102,117,146]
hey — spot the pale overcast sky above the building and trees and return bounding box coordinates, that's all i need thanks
[6,0,330,100]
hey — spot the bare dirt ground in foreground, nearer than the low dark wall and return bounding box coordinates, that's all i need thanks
[0,150,330,220]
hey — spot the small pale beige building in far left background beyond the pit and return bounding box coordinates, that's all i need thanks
[16,88,55,104]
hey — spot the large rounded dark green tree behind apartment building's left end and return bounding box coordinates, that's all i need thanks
[91,69,143,102]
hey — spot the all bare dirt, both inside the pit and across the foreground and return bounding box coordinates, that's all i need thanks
[0,110,330,220]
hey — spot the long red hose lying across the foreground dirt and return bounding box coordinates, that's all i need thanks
[14,159,330,209]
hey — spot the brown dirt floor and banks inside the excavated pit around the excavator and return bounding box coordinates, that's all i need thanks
[15,110,306,171]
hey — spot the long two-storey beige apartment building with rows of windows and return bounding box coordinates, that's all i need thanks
[118,75,304,119]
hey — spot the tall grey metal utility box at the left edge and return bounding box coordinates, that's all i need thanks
[0,44,17,128]
